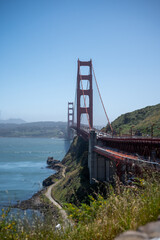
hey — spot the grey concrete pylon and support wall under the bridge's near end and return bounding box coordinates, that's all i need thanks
[88,130,116,184]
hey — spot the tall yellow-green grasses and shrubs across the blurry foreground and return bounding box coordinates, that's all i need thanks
[0,174,160,240]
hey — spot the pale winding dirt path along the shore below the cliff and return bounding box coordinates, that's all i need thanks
[45,167,73,226]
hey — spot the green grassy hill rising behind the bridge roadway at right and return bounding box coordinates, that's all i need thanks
[104,104,160,137]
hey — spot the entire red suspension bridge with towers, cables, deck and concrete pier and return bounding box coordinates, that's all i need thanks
[68,59,160,183]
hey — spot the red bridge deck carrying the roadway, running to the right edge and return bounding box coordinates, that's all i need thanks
[72,125,160,165]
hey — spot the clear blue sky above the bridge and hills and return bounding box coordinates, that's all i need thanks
[0,0,160,125]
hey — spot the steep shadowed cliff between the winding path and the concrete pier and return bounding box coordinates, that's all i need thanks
[62,137,107,205]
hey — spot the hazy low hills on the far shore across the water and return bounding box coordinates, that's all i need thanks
[0,122,67,138]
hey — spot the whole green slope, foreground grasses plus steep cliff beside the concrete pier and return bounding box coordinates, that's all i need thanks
[0,134,160,240]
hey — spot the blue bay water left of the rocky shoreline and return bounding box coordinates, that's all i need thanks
[0,138,70,208]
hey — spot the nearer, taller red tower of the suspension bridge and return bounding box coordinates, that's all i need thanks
[77,59,93,129]
